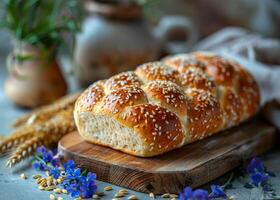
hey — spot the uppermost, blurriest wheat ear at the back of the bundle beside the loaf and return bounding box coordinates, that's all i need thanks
[12,92,81,127]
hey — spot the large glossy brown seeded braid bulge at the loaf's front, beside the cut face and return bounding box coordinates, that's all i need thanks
[120,104,185,156]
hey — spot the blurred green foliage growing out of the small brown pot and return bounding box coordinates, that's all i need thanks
[0,0,82,49]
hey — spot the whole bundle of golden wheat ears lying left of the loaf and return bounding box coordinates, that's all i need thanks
[3,94,78,167]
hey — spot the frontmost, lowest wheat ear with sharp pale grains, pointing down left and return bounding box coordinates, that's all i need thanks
[6,133,50,167]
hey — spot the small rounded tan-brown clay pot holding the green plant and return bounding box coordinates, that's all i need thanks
[4,43,67,108]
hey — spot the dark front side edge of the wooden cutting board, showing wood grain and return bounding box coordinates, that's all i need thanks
[58,127,277,194]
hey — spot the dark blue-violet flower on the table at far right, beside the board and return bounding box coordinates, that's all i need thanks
[247,158,268,187]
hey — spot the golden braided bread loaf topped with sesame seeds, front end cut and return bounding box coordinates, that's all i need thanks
[74,52,260,157]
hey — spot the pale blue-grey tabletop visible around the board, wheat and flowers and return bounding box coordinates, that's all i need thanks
[0,35,280,200]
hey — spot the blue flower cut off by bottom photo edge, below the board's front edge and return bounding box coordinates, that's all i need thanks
[179,187,209,200]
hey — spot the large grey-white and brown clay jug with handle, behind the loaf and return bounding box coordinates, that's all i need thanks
[74,1,197,86]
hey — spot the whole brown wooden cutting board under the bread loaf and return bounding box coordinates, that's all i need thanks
[59,120,277,194]
